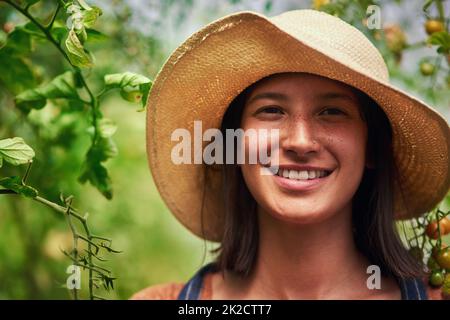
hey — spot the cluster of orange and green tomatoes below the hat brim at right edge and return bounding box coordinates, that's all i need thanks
[425,217,450,299]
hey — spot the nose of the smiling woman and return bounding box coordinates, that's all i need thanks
[280,119,320,157]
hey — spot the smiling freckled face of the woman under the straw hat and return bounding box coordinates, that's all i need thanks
[241,73,367,224]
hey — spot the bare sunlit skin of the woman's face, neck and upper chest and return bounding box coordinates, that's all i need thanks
[212,73,400,299]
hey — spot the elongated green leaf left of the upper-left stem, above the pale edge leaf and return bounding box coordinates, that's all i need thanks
[16,71,80,112]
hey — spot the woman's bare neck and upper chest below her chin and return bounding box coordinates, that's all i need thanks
[214,208,399,299]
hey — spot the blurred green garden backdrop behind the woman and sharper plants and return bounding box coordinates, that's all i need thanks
[0,0,450,299]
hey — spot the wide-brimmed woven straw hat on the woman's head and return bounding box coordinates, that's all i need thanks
[147,10,450,241]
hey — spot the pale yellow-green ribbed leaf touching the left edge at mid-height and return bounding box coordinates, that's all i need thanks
[0,137,35,166]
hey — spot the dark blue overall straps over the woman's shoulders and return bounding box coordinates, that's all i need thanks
[178,263,428,300]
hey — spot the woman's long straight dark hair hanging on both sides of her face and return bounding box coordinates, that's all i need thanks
[211,73,423,278]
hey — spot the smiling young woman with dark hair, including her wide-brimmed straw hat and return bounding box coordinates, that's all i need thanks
[133,10,450,299]
